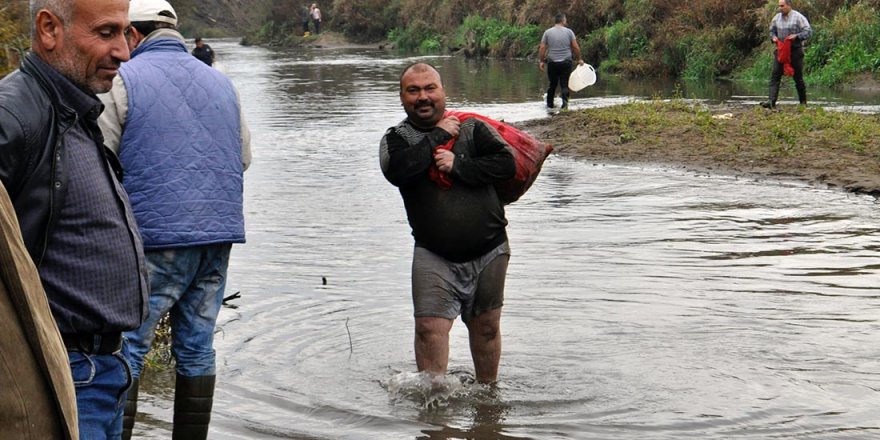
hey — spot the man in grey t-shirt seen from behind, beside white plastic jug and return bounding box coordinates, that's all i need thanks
[538,13,584,109]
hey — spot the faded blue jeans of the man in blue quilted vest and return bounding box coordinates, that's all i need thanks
[125,243,232,377]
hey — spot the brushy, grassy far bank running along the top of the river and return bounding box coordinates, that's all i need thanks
[251,0,880,85]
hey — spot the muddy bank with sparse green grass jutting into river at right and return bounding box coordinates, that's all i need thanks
[518,100,880,197]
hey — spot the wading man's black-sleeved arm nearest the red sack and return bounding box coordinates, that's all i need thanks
[452,123,516,186]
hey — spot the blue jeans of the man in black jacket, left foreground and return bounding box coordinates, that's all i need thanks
[67,341,131,440]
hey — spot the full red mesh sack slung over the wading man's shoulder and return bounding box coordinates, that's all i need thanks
[446,111,553,205]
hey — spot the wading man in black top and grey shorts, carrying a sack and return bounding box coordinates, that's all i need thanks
[379,63,516,383]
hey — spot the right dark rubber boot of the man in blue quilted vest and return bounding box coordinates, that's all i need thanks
[171,374,216,440]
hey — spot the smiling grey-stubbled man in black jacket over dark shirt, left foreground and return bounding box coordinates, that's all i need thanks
[0,0,148,440]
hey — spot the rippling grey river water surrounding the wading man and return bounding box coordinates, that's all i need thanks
[136,42,880,439]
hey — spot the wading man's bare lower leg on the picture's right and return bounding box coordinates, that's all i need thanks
[468,307,501,383]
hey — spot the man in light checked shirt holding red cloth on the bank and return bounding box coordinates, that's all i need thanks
[761,0,813,109]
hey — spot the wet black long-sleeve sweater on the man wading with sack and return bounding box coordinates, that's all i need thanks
[380,118,516,262]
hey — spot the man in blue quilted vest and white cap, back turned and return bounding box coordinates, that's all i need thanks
[99,0,250,440]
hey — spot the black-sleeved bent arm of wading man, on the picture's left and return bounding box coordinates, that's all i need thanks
[379,128,452,186]
